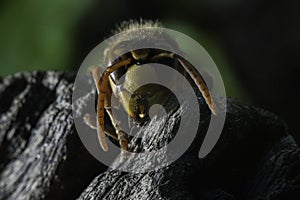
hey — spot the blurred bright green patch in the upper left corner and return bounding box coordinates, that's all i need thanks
[0,0,92,76]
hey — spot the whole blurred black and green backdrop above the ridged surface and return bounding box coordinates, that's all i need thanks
[0,0,300,144]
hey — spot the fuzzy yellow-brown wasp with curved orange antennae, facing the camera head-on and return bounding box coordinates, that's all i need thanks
[84,21,218,151]
